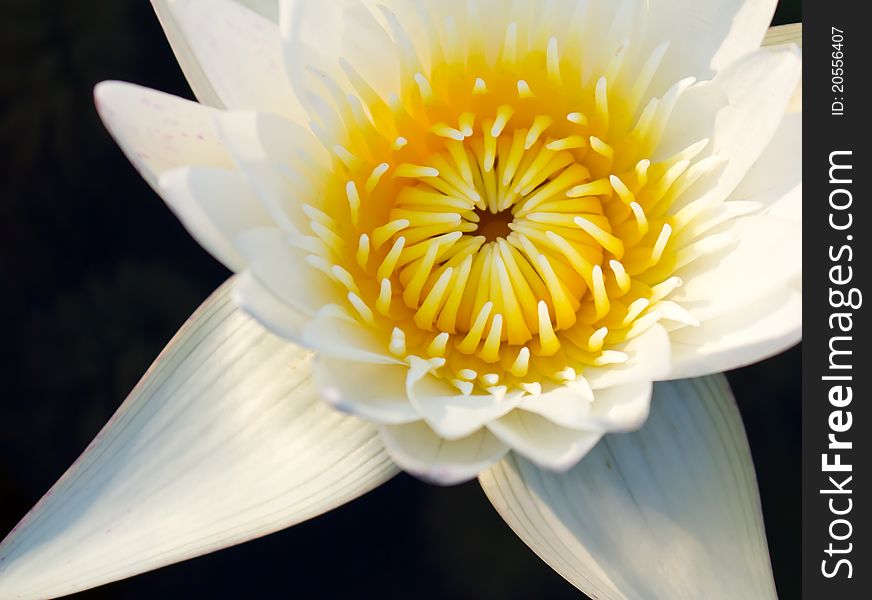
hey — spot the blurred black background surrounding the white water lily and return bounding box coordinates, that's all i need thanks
[0,0,801,599]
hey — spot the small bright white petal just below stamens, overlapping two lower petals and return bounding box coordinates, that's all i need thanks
[406,357,521,440]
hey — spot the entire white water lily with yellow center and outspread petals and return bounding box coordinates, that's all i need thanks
[0,0,801,598]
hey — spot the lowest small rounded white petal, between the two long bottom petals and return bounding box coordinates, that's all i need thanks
[381,421,508,485]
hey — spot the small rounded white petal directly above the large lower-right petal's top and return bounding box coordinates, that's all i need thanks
[487,410,603,471]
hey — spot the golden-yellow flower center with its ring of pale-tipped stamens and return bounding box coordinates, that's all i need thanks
[309,22,710,393]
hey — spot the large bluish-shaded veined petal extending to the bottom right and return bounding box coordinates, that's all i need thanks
[479,376,776,600]
